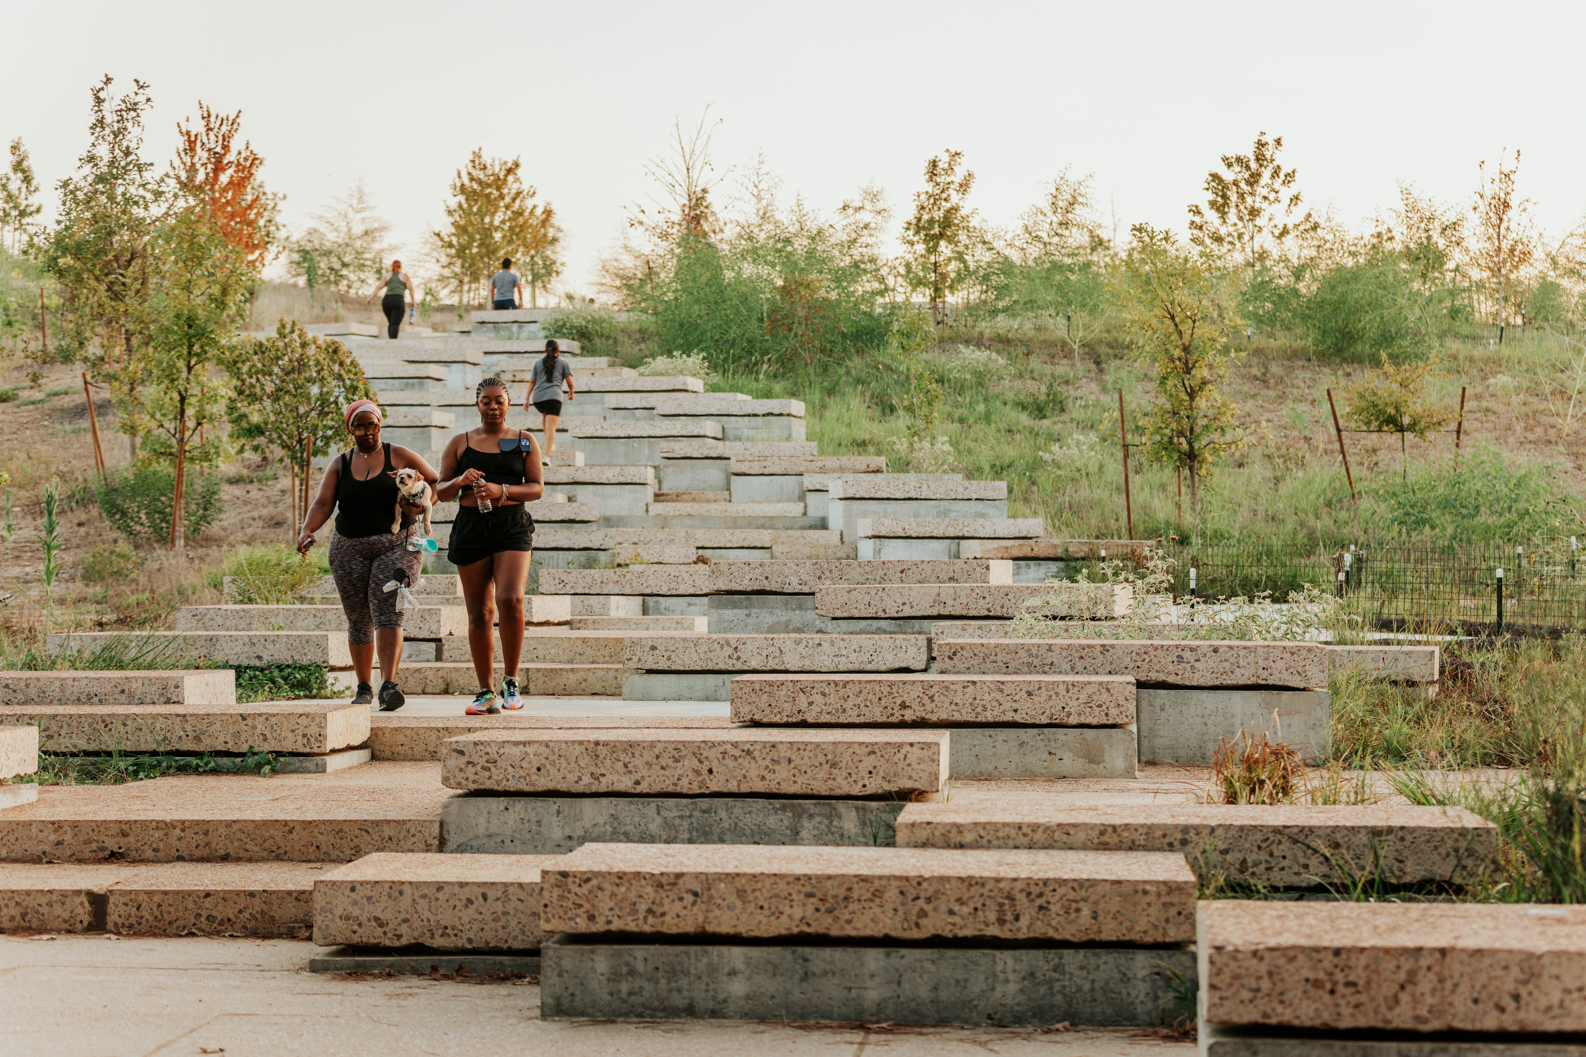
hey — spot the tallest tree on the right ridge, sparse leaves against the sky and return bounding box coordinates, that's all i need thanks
[1190,132,1320,273]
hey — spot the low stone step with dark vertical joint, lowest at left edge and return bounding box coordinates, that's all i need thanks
[0,862,335,936]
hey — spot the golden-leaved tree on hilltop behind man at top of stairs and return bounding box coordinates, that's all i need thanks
[431,151,560,305]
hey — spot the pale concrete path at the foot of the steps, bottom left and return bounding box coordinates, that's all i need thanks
[0,935,1194,1057]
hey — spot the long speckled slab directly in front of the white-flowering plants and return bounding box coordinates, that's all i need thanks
[934,640,1327,687]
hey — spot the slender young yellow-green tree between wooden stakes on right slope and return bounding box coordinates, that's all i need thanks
[1113,224,1245,543]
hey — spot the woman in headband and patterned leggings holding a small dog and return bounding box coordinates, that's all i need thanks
[298,400,439,713]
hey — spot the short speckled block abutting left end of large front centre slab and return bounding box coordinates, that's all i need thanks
[314,852,558,951]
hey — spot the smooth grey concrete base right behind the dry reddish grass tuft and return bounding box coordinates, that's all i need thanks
[1136,689,1332,763]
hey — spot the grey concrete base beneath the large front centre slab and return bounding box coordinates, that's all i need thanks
[541,936,1196,1027]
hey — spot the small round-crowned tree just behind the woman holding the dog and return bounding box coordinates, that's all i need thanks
[227,319,374,540]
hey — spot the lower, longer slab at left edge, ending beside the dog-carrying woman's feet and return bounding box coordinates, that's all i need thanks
[0,701,370,755]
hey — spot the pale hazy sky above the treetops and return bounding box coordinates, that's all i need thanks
[0,0,1586,286]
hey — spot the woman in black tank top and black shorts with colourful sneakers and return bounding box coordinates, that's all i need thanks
[436,378,546,716]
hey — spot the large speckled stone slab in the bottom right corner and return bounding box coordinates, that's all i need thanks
[1196,901,1586,1041]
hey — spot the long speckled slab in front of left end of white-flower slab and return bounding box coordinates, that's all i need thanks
[731,675,1134,727]
